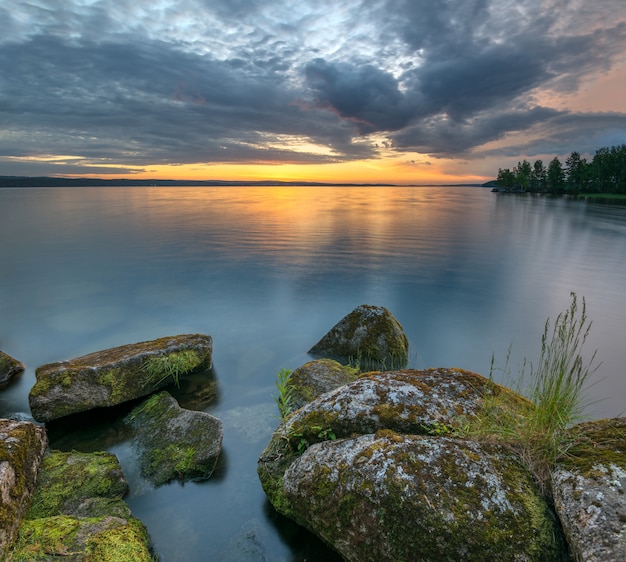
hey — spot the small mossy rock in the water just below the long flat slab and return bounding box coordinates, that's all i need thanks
[126,391,224,486]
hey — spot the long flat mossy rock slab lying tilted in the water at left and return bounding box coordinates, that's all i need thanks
[29,334,213,422]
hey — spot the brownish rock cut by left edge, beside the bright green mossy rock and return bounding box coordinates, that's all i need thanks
[0,420,48,559]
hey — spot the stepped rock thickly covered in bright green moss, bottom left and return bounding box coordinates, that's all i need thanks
[8,451,154,562]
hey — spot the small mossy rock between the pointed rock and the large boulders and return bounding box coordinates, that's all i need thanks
[289,359,359,410]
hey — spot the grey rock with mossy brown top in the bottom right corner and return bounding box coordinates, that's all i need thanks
[552,418,626,562]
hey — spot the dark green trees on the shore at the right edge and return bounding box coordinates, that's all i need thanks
[496,144,626,194]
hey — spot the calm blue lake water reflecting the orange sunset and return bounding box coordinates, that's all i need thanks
[0,187,626,562]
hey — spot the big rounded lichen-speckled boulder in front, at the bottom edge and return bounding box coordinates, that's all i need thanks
[283,433,558,562]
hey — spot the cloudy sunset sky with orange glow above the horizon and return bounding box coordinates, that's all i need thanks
[0,0,626,184]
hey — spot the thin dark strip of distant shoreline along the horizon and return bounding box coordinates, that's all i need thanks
[0,176,489,188]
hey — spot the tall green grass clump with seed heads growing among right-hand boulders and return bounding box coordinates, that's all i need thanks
[469,293,599,490]
